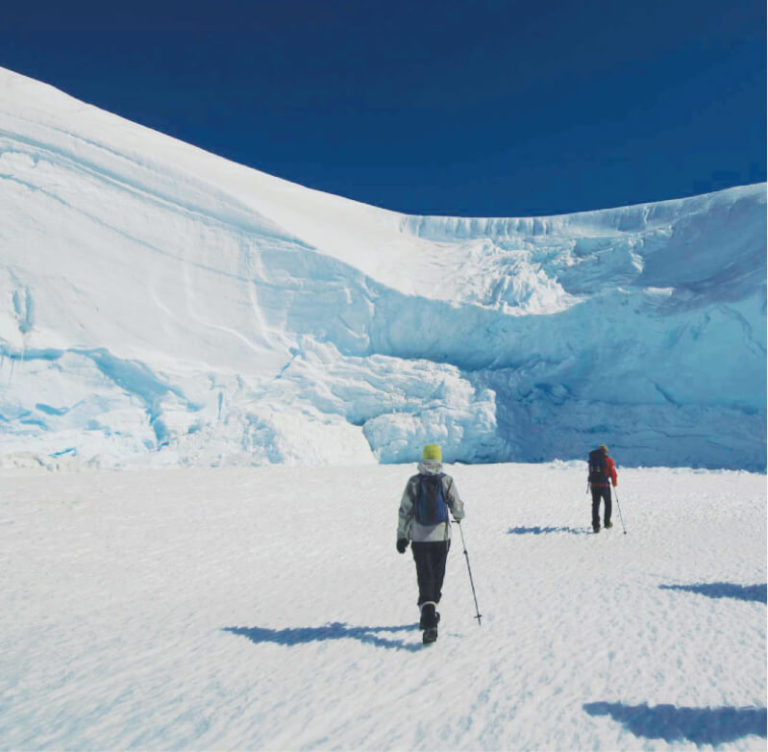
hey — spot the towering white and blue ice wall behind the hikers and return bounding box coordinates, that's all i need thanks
[0,70,766,469]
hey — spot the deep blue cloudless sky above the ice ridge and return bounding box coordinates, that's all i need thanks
[0,0,766,216]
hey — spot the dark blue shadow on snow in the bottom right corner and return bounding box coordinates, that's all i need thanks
[584,702,766,746]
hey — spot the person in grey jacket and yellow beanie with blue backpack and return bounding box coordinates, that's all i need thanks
[397,444,464,642]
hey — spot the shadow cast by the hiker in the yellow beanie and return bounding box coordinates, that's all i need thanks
[223,621,422,652]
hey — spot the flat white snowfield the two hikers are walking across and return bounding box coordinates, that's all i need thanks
[0,463,766,750]
